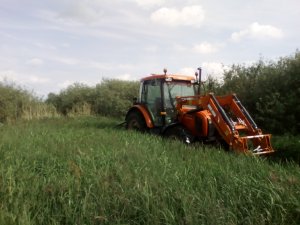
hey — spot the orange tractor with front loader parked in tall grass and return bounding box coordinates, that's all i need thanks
[125,68,274,155]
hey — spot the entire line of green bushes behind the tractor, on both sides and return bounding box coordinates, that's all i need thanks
[0,50,300,134]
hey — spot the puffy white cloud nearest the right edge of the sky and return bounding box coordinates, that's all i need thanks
[231,22,283,41]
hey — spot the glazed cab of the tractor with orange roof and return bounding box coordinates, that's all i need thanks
[138,73,197,127]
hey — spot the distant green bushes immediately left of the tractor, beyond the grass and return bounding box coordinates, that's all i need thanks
[46,79,139,117]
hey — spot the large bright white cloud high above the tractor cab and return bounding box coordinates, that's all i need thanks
[151,5,205,27]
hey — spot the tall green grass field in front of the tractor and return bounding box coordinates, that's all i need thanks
[0,117,300,225]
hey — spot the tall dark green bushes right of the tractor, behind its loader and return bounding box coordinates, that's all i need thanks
[213,51,300,134]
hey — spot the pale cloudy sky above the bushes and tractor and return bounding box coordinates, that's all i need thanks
[0,0,300,97]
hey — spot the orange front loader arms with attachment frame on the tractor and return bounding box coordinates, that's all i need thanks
[177,94,274,155]
